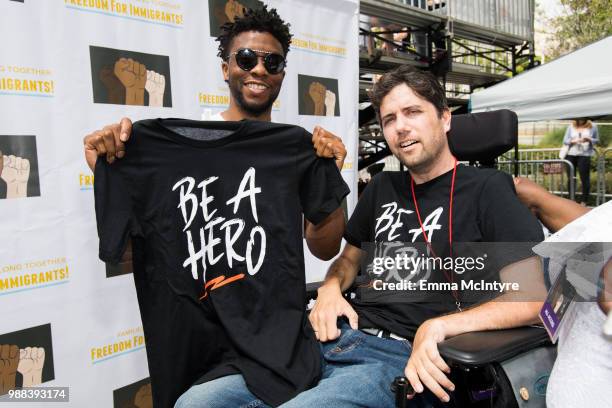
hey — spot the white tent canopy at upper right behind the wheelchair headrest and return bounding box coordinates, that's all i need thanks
[470,36,612,122]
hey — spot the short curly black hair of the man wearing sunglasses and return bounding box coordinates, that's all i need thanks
[216,5,291,61]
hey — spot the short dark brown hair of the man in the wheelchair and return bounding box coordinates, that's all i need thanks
[370,65,448,119]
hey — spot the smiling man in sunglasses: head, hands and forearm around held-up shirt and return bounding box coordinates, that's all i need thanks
[83,10,346,260]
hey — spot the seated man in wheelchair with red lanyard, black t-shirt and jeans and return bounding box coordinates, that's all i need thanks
[294,67,545,407]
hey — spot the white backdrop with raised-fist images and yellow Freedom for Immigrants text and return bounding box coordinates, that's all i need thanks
[0,0,359,408]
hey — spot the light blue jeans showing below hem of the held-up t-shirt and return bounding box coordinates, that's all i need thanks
[174,374,269,408]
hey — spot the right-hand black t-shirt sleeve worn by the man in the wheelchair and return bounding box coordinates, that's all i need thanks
[479,172,544,267]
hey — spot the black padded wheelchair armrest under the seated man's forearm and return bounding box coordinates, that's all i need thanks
[438,326,551,366]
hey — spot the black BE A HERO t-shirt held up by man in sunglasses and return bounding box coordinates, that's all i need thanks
[94,119,349,407]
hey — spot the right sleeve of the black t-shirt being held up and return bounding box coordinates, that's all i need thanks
[297,131,350,225]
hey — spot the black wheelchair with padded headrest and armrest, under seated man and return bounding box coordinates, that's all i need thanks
[307,110,556,408]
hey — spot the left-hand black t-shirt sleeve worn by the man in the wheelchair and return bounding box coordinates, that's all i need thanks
[344,174,382,248]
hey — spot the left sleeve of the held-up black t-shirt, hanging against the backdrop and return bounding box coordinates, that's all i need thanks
[94,157,135,263]
